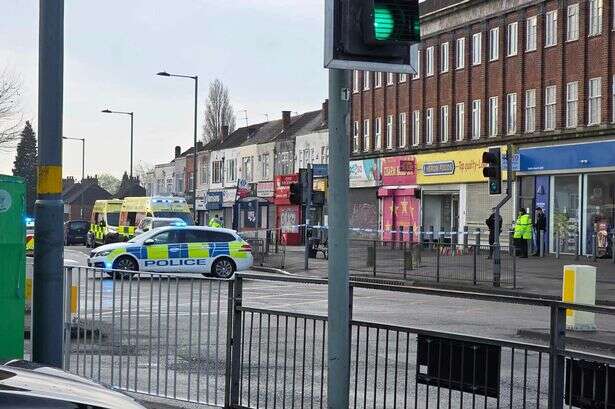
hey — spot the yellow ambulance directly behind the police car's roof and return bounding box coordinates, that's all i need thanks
[118,196,194,237]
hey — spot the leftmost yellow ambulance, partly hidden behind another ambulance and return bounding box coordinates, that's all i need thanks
[86,199,122,248]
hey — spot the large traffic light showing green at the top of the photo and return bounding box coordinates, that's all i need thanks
[325,0,421,73]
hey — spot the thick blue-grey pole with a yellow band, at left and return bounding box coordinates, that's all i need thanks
[32,0,64,367]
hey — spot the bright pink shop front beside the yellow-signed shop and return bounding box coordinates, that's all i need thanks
[378,155,421,241]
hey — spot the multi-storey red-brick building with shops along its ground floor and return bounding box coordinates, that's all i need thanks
[350,0,615,253]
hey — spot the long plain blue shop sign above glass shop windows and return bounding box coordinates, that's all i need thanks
[519,141,615,172]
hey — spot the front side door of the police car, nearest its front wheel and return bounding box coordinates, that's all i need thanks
[139,230,185,273]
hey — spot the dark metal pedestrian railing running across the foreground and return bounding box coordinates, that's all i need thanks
[65,268,615,409]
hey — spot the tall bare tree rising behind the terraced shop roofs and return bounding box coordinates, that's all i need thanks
[203,79,235,143]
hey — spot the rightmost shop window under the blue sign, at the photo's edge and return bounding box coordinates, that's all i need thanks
[584,173,615,257]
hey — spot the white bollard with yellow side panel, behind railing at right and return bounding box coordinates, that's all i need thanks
[562,265,596,331]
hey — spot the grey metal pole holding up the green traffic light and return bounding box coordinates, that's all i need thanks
[327,69,350,408]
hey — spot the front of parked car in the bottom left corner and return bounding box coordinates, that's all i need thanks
[0,360,144,409]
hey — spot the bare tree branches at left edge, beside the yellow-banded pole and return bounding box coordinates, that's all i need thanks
[0,70,22,149]
